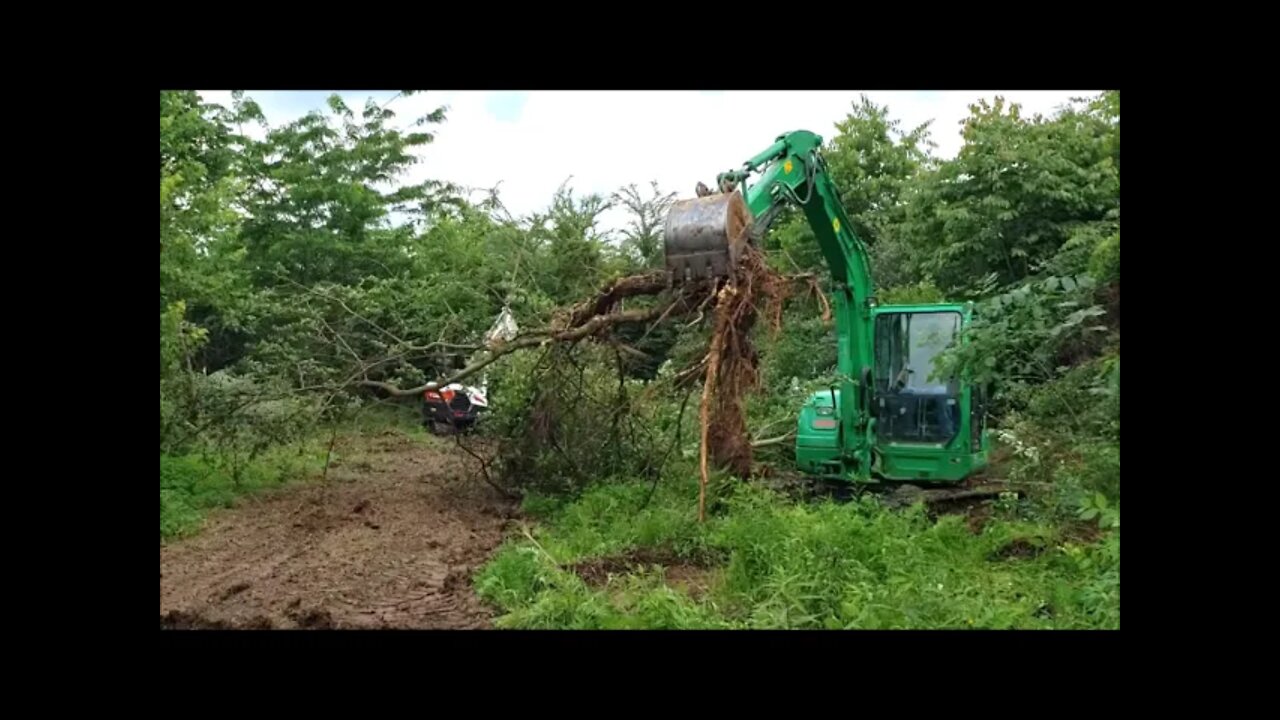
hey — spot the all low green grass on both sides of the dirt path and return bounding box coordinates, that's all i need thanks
[160,397,1120,629]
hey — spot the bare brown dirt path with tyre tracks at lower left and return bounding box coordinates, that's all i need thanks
[160,434,515,629]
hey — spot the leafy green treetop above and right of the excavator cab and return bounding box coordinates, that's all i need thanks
[902,97,1120,293]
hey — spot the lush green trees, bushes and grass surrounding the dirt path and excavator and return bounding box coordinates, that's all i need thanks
[159,91,1120,628]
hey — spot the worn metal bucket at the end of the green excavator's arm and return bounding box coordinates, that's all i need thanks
[663,192,751,284]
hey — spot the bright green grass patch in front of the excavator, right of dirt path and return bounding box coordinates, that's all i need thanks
[476,466,1120,629]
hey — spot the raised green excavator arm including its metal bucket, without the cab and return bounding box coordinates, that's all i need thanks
[664,131,874,477]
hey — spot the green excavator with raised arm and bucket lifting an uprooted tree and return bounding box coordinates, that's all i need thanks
[663,131,989,484]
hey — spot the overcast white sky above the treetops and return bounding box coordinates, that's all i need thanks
[200,90,1098,235]
